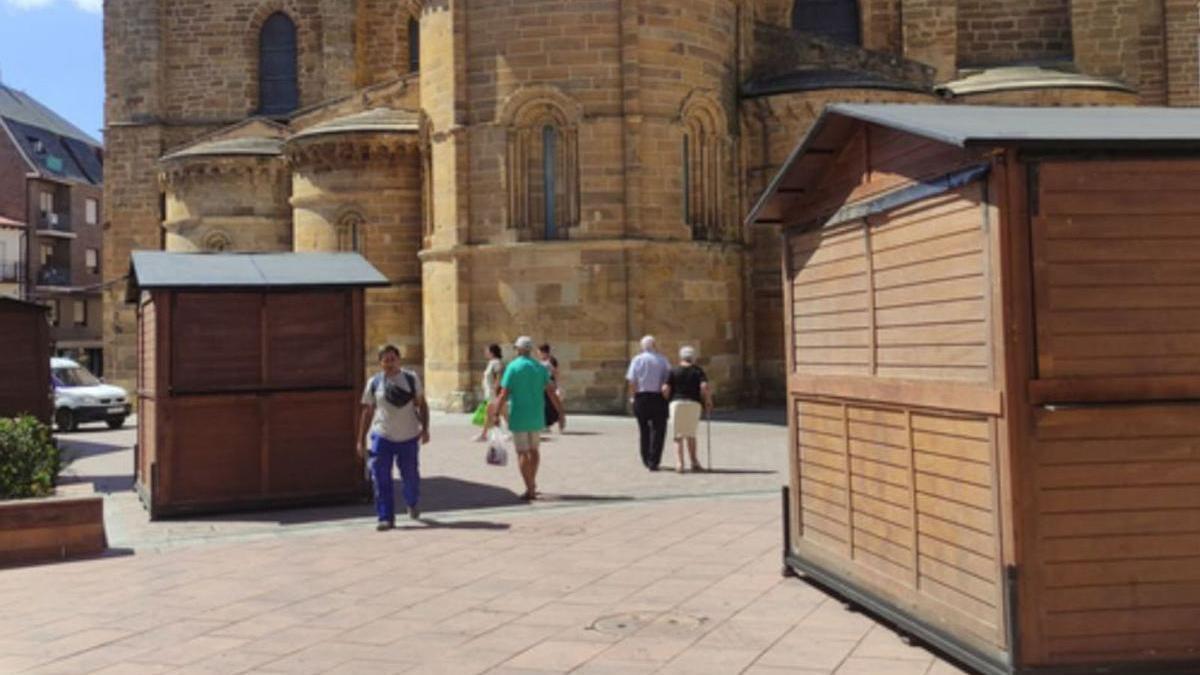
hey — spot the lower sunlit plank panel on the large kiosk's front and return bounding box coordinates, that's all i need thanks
[793,398,1004,645]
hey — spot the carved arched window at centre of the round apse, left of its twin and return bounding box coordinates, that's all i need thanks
[497,86,583,239]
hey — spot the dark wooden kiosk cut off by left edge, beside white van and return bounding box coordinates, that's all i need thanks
[0,295,54,424]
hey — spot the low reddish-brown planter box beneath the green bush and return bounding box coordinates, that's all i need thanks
[0,489,107,567]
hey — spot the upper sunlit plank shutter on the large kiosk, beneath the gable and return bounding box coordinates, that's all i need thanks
[787,183,992,382]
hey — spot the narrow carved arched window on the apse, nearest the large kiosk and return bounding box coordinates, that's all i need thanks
[678,89,733,241]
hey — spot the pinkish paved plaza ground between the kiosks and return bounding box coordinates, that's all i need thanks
[0,413,959,675]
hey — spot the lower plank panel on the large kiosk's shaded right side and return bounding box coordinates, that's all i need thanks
[1030,404,1200,663]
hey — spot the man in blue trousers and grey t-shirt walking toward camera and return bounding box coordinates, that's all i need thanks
[358,345,430,531]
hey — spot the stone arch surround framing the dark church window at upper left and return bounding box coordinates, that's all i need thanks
[242,0,323,114]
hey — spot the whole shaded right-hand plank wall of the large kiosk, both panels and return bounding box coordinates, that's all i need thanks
[1022,160,1200,663]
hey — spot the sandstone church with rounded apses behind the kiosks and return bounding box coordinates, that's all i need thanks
[103,0,1200,411]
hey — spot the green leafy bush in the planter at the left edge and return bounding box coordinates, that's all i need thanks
[0,416,62,500]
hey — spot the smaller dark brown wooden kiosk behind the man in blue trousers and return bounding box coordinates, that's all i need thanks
[127,251,386,518]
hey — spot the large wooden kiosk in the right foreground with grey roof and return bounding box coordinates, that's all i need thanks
[750,106,1200,674]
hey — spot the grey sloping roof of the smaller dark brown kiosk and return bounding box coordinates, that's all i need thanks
[126,251,388,301]
